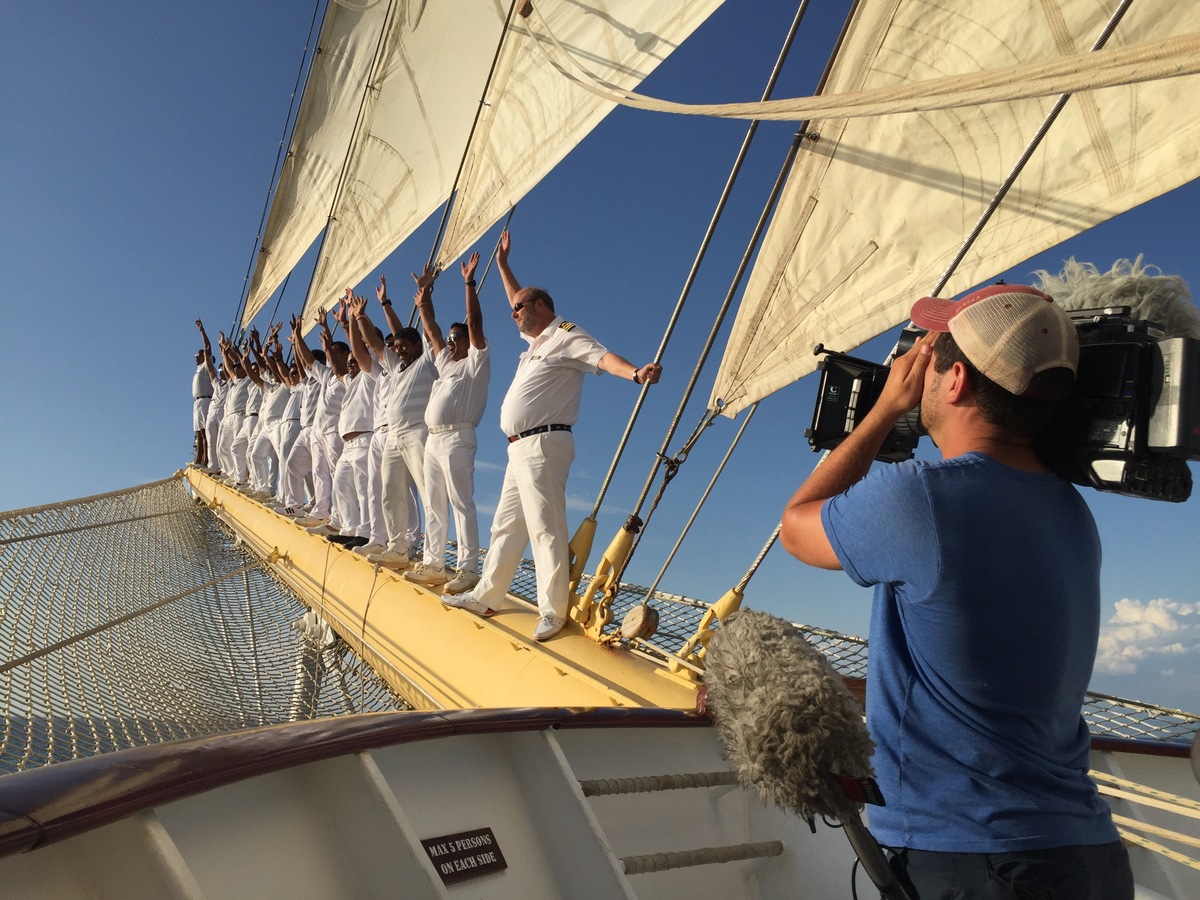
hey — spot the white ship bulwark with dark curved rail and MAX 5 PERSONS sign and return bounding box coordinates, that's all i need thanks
[0,709,1200,900]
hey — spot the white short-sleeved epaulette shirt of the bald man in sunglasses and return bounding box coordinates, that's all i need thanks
[500,316,608,436]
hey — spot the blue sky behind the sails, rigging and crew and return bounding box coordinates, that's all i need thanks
[0,0,1200,710]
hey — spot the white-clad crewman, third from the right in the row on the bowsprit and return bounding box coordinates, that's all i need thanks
[360,277,444,571]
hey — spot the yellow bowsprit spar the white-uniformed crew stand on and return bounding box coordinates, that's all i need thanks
[185,468,696,709]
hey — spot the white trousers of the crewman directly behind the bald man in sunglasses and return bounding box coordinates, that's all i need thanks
[425,428,479,572]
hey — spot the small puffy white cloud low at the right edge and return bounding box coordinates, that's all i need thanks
[1096,598,1200,674]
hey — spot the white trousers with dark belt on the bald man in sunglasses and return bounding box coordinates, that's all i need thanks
[470,431,575,617]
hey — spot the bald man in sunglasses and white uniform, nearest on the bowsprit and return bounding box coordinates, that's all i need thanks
[442,232,662,641]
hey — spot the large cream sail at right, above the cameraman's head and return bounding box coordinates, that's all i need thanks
[710,0,1200,416]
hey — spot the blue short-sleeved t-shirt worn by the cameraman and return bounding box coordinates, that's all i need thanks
[822,454,1117,853]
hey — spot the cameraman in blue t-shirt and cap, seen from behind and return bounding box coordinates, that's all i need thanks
[781,284,1133,900]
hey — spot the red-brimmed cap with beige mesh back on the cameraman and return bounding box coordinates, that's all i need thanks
[910,284,1079,395]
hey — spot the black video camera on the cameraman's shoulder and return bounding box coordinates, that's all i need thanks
[804,306,1200,503]
